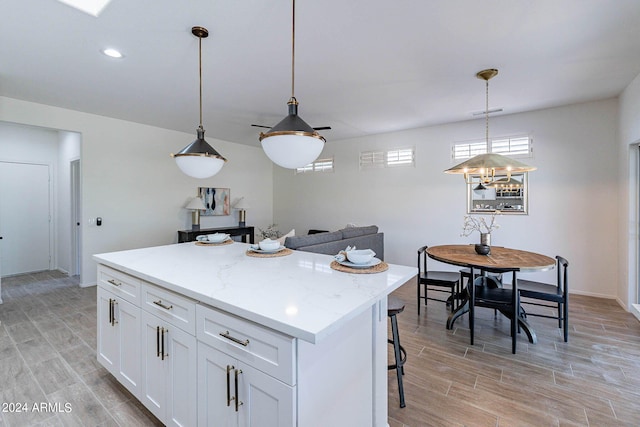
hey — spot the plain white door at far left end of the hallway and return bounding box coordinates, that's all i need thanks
[0,162,51,276]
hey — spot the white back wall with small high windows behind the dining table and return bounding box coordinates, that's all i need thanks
[274,99,619,298]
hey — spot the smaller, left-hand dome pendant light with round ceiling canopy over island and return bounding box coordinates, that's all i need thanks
[171,27,227,178]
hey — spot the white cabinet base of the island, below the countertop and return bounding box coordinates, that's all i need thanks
[97,258,388,427]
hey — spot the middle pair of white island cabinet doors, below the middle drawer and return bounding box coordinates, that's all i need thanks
[140,310,197,426]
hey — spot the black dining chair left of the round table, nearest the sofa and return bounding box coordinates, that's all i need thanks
[417,246,460,316]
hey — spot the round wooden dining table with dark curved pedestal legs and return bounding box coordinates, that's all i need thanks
[427,245,556,343]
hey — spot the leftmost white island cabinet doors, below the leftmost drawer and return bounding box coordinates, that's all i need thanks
[97,286,141,396]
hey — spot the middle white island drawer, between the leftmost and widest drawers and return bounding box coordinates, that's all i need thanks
[142,283,196,335]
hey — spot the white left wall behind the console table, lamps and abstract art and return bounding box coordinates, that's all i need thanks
[0,97,273,285]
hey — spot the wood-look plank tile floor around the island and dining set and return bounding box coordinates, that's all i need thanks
[0,272,640,427]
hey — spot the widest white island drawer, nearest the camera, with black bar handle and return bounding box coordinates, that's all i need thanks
[196,304,297,386]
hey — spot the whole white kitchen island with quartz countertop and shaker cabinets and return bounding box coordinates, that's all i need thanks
[94,242,417,427]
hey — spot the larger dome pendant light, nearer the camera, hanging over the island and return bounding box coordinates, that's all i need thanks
[259,0,326,169]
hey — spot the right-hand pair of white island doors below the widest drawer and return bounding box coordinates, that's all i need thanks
[198,320,296,427]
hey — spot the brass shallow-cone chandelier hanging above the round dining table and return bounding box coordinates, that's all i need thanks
[444,68,536,184]
